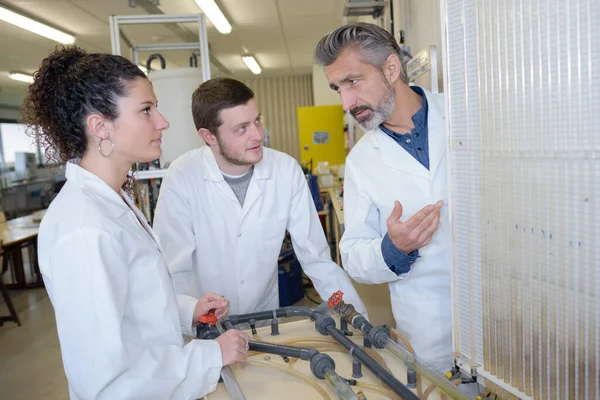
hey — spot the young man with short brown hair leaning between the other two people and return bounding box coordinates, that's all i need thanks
[154,78,366,324]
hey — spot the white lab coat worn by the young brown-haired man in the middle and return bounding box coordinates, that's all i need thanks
[154,146,365,320]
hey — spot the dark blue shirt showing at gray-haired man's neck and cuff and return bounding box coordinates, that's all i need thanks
[379,86,429,275]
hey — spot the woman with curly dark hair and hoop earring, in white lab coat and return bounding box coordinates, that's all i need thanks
[23,47,248,400]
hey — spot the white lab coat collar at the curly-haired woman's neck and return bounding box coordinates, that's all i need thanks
[65,159,129,218]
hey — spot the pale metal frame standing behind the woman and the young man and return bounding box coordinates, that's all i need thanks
[109,14,210,81]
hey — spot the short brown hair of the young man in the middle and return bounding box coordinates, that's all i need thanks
[192,78,254,135]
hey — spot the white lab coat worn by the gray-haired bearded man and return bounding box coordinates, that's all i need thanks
[340,91,452,372]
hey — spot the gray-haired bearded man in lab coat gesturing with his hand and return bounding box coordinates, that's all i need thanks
[315,23,453,372]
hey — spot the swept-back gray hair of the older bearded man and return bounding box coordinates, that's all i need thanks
[314,22,408,83]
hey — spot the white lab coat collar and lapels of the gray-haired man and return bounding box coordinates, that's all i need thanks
[371,89,446,179]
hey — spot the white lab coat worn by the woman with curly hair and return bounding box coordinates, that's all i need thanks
[38,163,222,400]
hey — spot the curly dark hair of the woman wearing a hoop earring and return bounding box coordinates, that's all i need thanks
[23,45,147,162]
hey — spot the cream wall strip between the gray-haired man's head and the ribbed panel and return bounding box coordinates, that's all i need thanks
[392,0,444,92]
